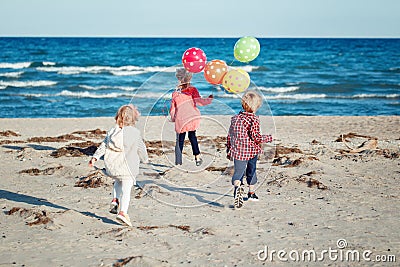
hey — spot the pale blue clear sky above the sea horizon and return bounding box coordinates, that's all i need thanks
[0,0,400,38]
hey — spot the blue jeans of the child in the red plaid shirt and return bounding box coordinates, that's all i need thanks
[232,155,258,185]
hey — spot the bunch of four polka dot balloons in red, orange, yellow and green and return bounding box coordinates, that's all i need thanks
[182,36,260,93]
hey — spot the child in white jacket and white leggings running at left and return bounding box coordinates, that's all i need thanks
[89,104,148,226]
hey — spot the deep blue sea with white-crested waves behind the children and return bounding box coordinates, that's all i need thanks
[0,37,400,118]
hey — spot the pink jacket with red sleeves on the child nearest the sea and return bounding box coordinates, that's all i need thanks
[169,87,212,133]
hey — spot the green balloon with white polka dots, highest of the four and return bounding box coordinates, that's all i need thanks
[233,36,260,63]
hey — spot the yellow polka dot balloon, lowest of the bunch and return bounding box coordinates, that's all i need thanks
[222,69,250,94]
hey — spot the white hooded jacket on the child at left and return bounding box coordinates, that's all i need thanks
[93,125,148,179]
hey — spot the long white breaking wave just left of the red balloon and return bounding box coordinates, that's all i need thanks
[36,66,170,76]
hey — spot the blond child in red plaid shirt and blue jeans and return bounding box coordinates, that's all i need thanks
[226,91,272,208]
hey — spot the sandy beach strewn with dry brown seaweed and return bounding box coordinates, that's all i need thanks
[0,116,400,266]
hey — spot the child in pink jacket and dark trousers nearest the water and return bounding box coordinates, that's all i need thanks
[169,68,213,166]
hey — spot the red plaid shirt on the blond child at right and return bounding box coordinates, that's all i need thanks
[226,111,272,160]
